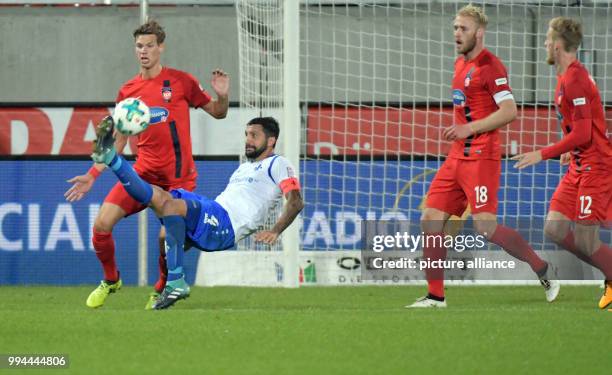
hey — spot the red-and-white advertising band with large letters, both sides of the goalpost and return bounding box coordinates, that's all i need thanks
[0,106,612,156]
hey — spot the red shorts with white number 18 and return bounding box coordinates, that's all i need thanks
[425,158,501,216]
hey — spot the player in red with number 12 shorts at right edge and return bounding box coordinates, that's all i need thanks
[514,17,612,309]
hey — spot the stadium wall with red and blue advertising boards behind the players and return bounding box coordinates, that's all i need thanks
[0,1,612,284]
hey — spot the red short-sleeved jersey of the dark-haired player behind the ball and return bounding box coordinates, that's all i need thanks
[117,67,211,185]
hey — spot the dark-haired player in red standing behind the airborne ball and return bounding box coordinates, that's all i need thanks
[65,21,229,307]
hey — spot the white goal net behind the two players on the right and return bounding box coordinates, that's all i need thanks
[226,0,612,283]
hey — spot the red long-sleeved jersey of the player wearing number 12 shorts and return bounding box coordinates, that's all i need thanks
[542,61,612,173]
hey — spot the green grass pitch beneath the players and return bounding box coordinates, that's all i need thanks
[0,286,612,375]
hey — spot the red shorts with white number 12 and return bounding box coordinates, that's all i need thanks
[549,169,612,224]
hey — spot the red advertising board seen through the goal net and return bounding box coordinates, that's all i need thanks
[307,106,612,156]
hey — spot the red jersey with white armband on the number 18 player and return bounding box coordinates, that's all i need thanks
[448,49,514,160]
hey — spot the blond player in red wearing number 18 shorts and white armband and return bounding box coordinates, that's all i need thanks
[406,5,559,307]
